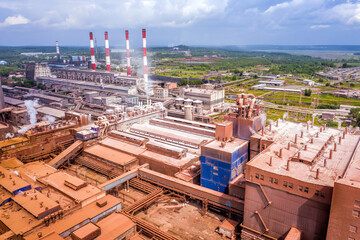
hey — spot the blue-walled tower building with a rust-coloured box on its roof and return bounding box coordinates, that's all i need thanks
[201,122,248,193]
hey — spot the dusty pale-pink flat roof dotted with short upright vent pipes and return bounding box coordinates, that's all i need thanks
[248,121,360,186]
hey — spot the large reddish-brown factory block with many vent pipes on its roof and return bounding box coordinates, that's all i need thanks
[239,120,360,239]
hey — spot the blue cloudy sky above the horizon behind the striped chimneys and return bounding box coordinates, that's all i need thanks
[0,0,360,47]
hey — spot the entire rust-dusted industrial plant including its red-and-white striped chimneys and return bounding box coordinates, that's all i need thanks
[0,29,360,240]
